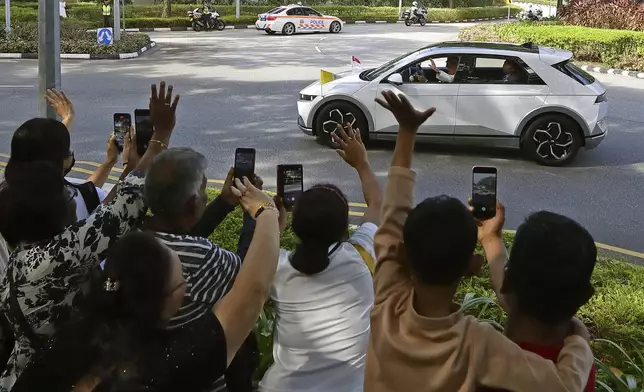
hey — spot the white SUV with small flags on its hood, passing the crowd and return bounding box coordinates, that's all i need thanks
[297,42,608,166]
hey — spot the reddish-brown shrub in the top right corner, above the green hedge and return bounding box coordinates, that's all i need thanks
[559,0,644,31]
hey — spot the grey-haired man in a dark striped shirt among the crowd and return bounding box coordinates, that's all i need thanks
[144,148,262,391]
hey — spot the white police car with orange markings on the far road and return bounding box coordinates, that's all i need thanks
[255,4,344,35]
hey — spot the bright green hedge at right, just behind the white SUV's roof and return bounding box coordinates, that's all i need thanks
[459,22,644,71]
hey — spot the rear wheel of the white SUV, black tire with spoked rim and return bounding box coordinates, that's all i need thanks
[521,114,584,166]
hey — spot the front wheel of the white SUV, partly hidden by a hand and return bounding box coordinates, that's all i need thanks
[313,101,369,146]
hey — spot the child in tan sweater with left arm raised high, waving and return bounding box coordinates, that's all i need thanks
[364,91,593,392]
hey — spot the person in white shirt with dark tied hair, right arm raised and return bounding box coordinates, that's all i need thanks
[259,126,382,392]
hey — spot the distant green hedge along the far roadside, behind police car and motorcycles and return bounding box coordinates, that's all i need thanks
[0,3,521,28]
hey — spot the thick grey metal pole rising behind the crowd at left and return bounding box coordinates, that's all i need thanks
[38,0,60,118]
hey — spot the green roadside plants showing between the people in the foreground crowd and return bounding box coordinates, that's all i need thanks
[203,189,644,388]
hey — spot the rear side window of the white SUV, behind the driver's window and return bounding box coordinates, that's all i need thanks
[462,55,545,85]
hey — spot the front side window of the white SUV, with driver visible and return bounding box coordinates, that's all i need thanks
[398,55,462,84]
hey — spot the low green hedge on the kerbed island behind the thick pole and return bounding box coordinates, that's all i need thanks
[0,22,150,54]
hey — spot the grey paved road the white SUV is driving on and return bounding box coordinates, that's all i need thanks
[0,24,644,258]
